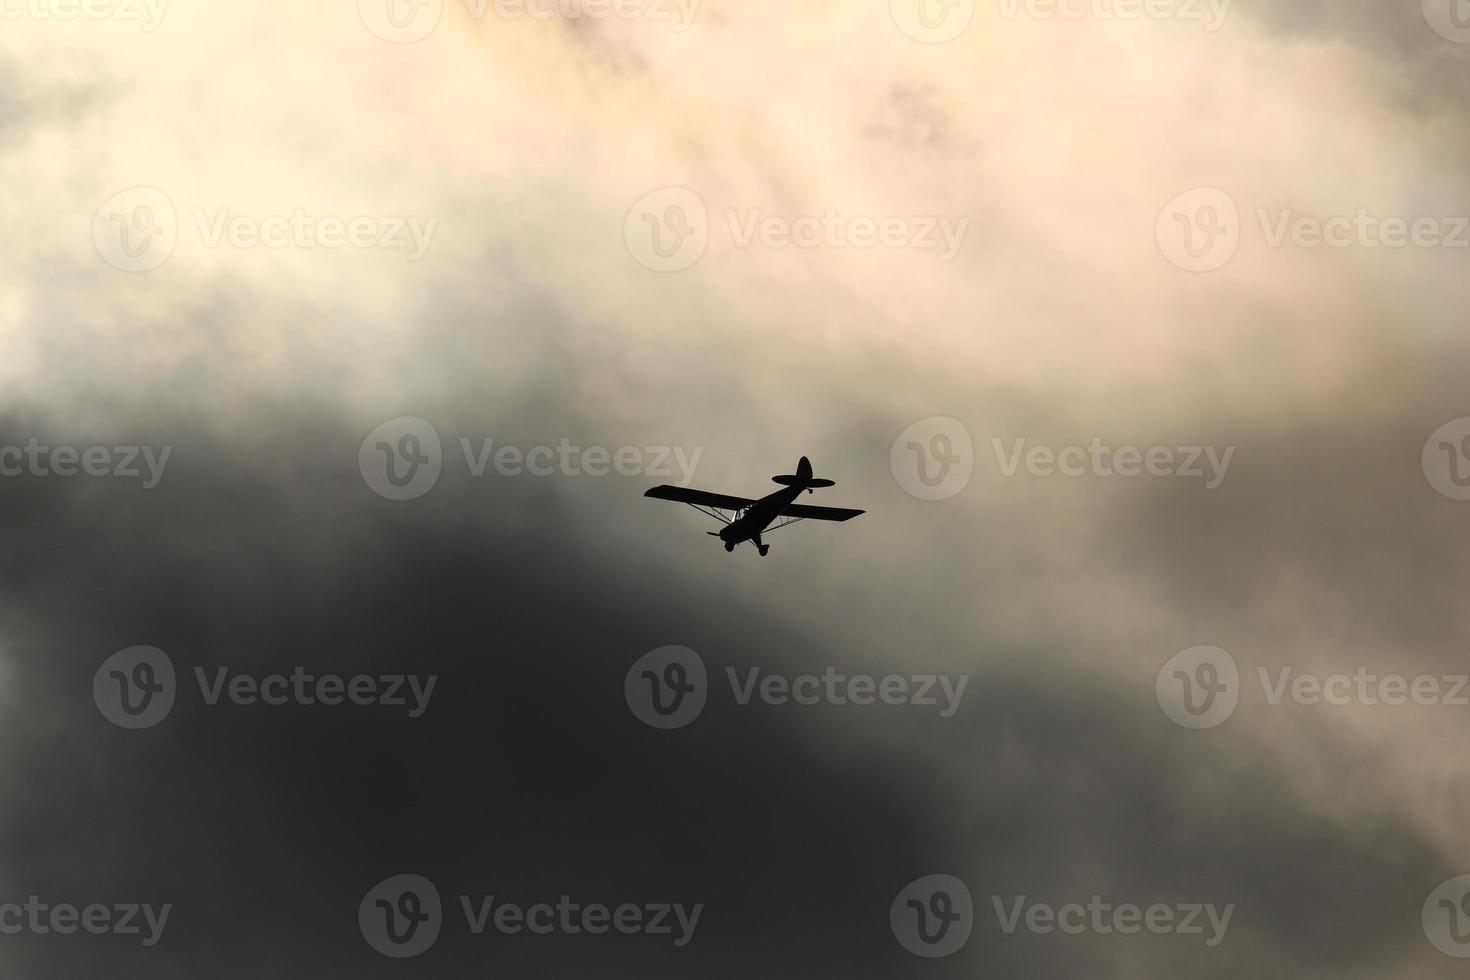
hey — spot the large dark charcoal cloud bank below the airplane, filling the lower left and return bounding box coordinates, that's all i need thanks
[0,387,1446,977]
